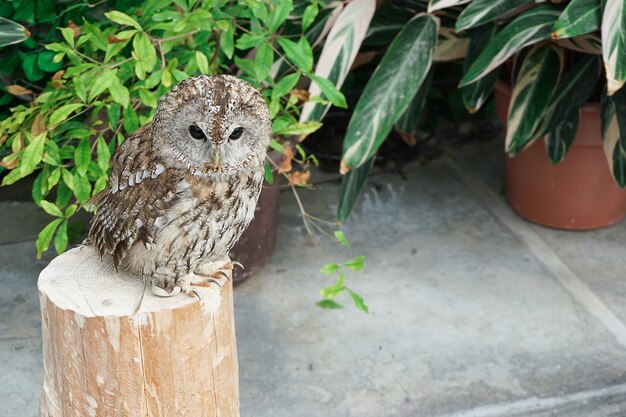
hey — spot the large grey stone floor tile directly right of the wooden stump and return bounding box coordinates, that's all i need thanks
[236,158,626,417]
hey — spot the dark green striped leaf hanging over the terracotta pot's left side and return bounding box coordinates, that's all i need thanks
[505,44,564,156]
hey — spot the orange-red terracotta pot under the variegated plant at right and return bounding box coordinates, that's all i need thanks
[495,82,626,230]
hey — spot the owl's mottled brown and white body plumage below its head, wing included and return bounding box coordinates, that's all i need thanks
[86,128,263,268]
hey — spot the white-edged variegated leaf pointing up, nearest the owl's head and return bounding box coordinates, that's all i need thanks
[300,0,376,122]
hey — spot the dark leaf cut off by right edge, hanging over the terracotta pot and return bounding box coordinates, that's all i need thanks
[602,88,626,188]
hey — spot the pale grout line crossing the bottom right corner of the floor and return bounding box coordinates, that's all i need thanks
[441,384,626,417]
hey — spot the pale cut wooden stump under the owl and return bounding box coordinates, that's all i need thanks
[38,247,239,417]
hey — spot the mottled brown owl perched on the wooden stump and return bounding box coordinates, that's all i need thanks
[85,75,271,296]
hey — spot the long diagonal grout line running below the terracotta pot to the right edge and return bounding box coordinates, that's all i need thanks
[446,150,626,348]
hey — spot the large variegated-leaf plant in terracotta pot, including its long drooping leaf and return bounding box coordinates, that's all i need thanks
[322,0,626,228]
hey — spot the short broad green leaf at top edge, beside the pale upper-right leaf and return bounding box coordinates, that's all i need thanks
[552,0,600,39]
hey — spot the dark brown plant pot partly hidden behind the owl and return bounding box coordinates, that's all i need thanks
[230,180,279,284]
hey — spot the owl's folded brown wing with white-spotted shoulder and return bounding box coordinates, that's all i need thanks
[88,128,179,268]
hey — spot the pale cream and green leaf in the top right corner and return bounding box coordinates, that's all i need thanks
[602,0,626,95]
